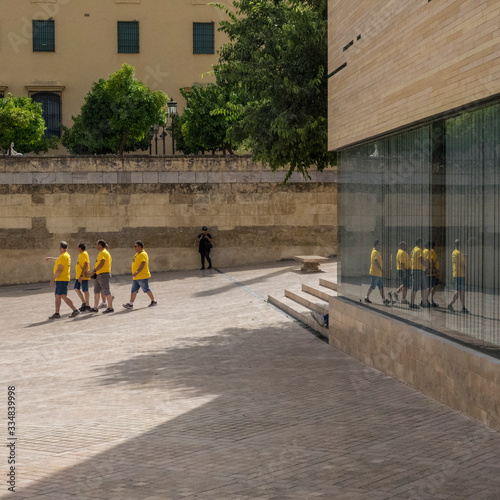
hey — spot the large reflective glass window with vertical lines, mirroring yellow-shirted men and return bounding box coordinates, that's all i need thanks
[339,105,500,348]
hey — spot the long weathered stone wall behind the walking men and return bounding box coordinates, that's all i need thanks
[0,156,337,285]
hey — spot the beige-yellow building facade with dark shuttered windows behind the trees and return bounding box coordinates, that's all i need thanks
[0,0,225,152]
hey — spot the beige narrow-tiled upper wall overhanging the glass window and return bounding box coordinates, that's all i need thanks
[328,0,500,150]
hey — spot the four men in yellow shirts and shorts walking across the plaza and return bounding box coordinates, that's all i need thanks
[45,240,157,319]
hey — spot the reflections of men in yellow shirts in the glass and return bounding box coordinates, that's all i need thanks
[365,238,469,314]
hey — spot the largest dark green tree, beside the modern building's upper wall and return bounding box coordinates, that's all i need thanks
[214,0,335,178]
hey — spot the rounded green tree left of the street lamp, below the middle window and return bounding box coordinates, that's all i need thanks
[62,64,167,155]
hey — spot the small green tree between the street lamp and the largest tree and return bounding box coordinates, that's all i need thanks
[174,84,244,154]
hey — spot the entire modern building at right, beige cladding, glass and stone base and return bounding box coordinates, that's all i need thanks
[328,0,500,429]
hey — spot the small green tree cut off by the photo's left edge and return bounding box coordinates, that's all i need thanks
[0,94,58,153]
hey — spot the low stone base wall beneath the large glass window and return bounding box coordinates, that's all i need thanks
[329,298,500,431]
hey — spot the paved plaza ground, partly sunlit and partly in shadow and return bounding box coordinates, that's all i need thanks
[0,262,500,500]
